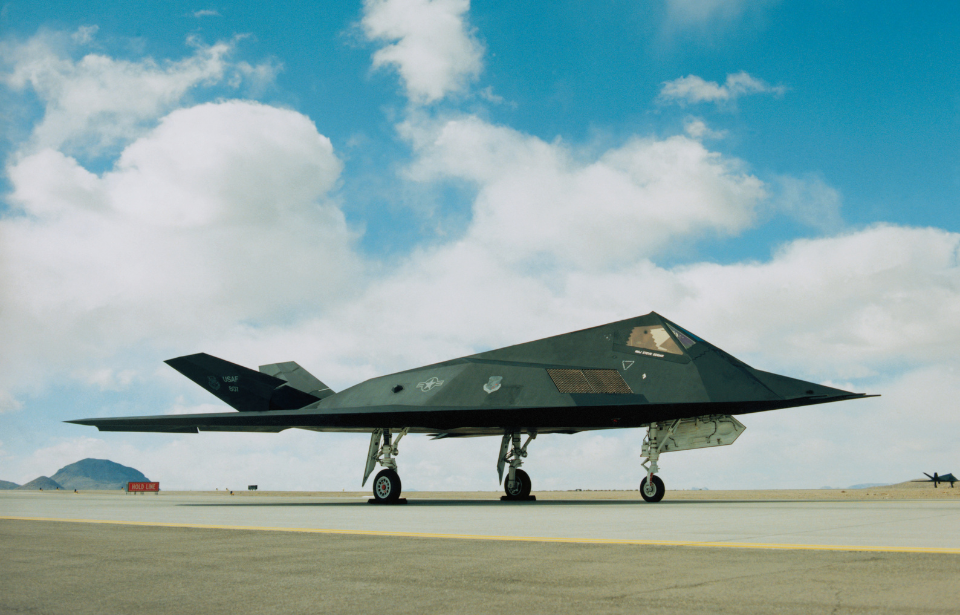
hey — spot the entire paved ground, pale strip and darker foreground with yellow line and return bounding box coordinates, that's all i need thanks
[0,492,960,614]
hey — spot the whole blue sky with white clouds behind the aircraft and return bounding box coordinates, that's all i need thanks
[0,0,960,488]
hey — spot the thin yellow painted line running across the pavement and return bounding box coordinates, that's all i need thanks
[0,516,960,555]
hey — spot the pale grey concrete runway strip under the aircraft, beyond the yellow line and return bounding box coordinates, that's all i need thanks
[0,492,960,554]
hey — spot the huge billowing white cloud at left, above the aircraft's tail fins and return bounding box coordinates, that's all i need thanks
[0,101,362,402]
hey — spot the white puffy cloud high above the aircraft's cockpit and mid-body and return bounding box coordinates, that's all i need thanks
[401,117,765,268]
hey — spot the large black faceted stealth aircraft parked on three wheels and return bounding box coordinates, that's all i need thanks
[69,312,870,502]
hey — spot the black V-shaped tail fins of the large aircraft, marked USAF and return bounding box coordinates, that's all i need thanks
[165,352,333,412]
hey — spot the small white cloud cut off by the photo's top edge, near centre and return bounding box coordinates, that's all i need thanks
[361,0,483,103]
